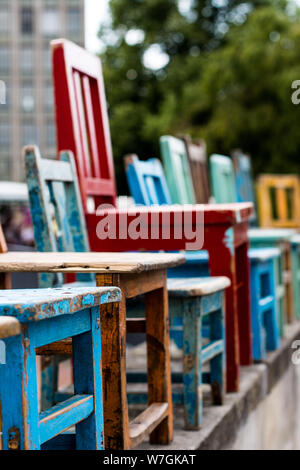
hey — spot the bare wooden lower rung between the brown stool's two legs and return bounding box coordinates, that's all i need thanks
[129,403,169,448]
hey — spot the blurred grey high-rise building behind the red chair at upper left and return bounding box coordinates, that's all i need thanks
[0,0,84,181]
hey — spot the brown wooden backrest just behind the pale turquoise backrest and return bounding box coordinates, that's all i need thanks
[181,136,211,204]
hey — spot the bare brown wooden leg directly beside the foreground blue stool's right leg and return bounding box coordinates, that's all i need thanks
[97,274,130,450]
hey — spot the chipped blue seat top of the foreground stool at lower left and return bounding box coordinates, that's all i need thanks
[0,287,121,323]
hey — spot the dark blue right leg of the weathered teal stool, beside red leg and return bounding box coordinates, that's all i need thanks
[210,302,226,405]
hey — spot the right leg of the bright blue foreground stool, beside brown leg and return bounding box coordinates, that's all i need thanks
[72,307,104,450]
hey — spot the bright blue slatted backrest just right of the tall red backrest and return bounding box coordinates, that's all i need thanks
[124,155,172,206]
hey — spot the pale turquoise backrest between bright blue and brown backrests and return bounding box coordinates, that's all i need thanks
[160,136,196,204]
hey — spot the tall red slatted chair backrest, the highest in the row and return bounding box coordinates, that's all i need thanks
[51,39,117,213]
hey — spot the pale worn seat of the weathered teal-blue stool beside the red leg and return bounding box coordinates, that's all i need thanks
[168,276,230,297]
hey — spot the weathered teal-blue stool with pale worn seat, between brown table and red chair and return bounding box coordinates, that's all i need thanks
[168,277,230,429]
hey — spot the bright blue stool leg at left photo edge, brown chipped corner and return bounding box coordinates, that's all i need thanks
[0,335,40,450]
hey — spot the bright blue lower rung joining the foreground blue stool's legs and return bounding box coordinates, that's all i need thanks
[39,395,94,444]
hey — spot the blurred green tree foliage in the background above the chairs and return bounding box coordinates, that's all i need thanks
[100,0,300,193]
